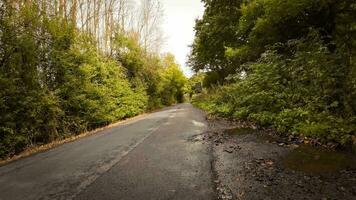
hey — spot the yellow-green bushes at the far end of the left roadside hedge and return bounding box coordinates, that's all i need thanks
[113,34,187,109]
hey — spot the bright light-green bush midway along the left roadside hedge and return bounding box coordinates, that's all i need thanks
[58,36,148,131]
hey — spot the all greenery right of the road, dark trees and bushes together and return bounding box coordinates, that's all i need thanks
[189,0,356,145]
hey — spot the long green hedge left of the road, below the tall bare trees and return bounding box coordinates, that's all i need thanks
[0,3,186,158]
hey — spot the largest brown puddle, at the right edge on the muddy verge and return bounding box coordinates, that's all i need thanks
[283,146,356,174]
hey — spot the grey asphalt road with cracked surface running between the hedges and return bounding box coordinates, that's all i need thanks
[0,104,215,200]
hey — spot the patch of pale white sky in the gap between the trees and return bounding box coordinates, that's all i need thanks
[161,0,204,77]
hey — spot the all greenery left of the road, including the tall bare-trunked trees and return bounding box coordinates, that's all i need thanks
[0,0,187,159]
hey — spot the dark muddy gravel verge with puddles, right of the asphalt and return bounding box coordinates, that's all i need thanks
[199,120,356,200]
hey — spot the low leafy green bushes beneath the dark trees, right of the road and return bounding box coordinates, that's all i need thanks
[194,32,356,144]
